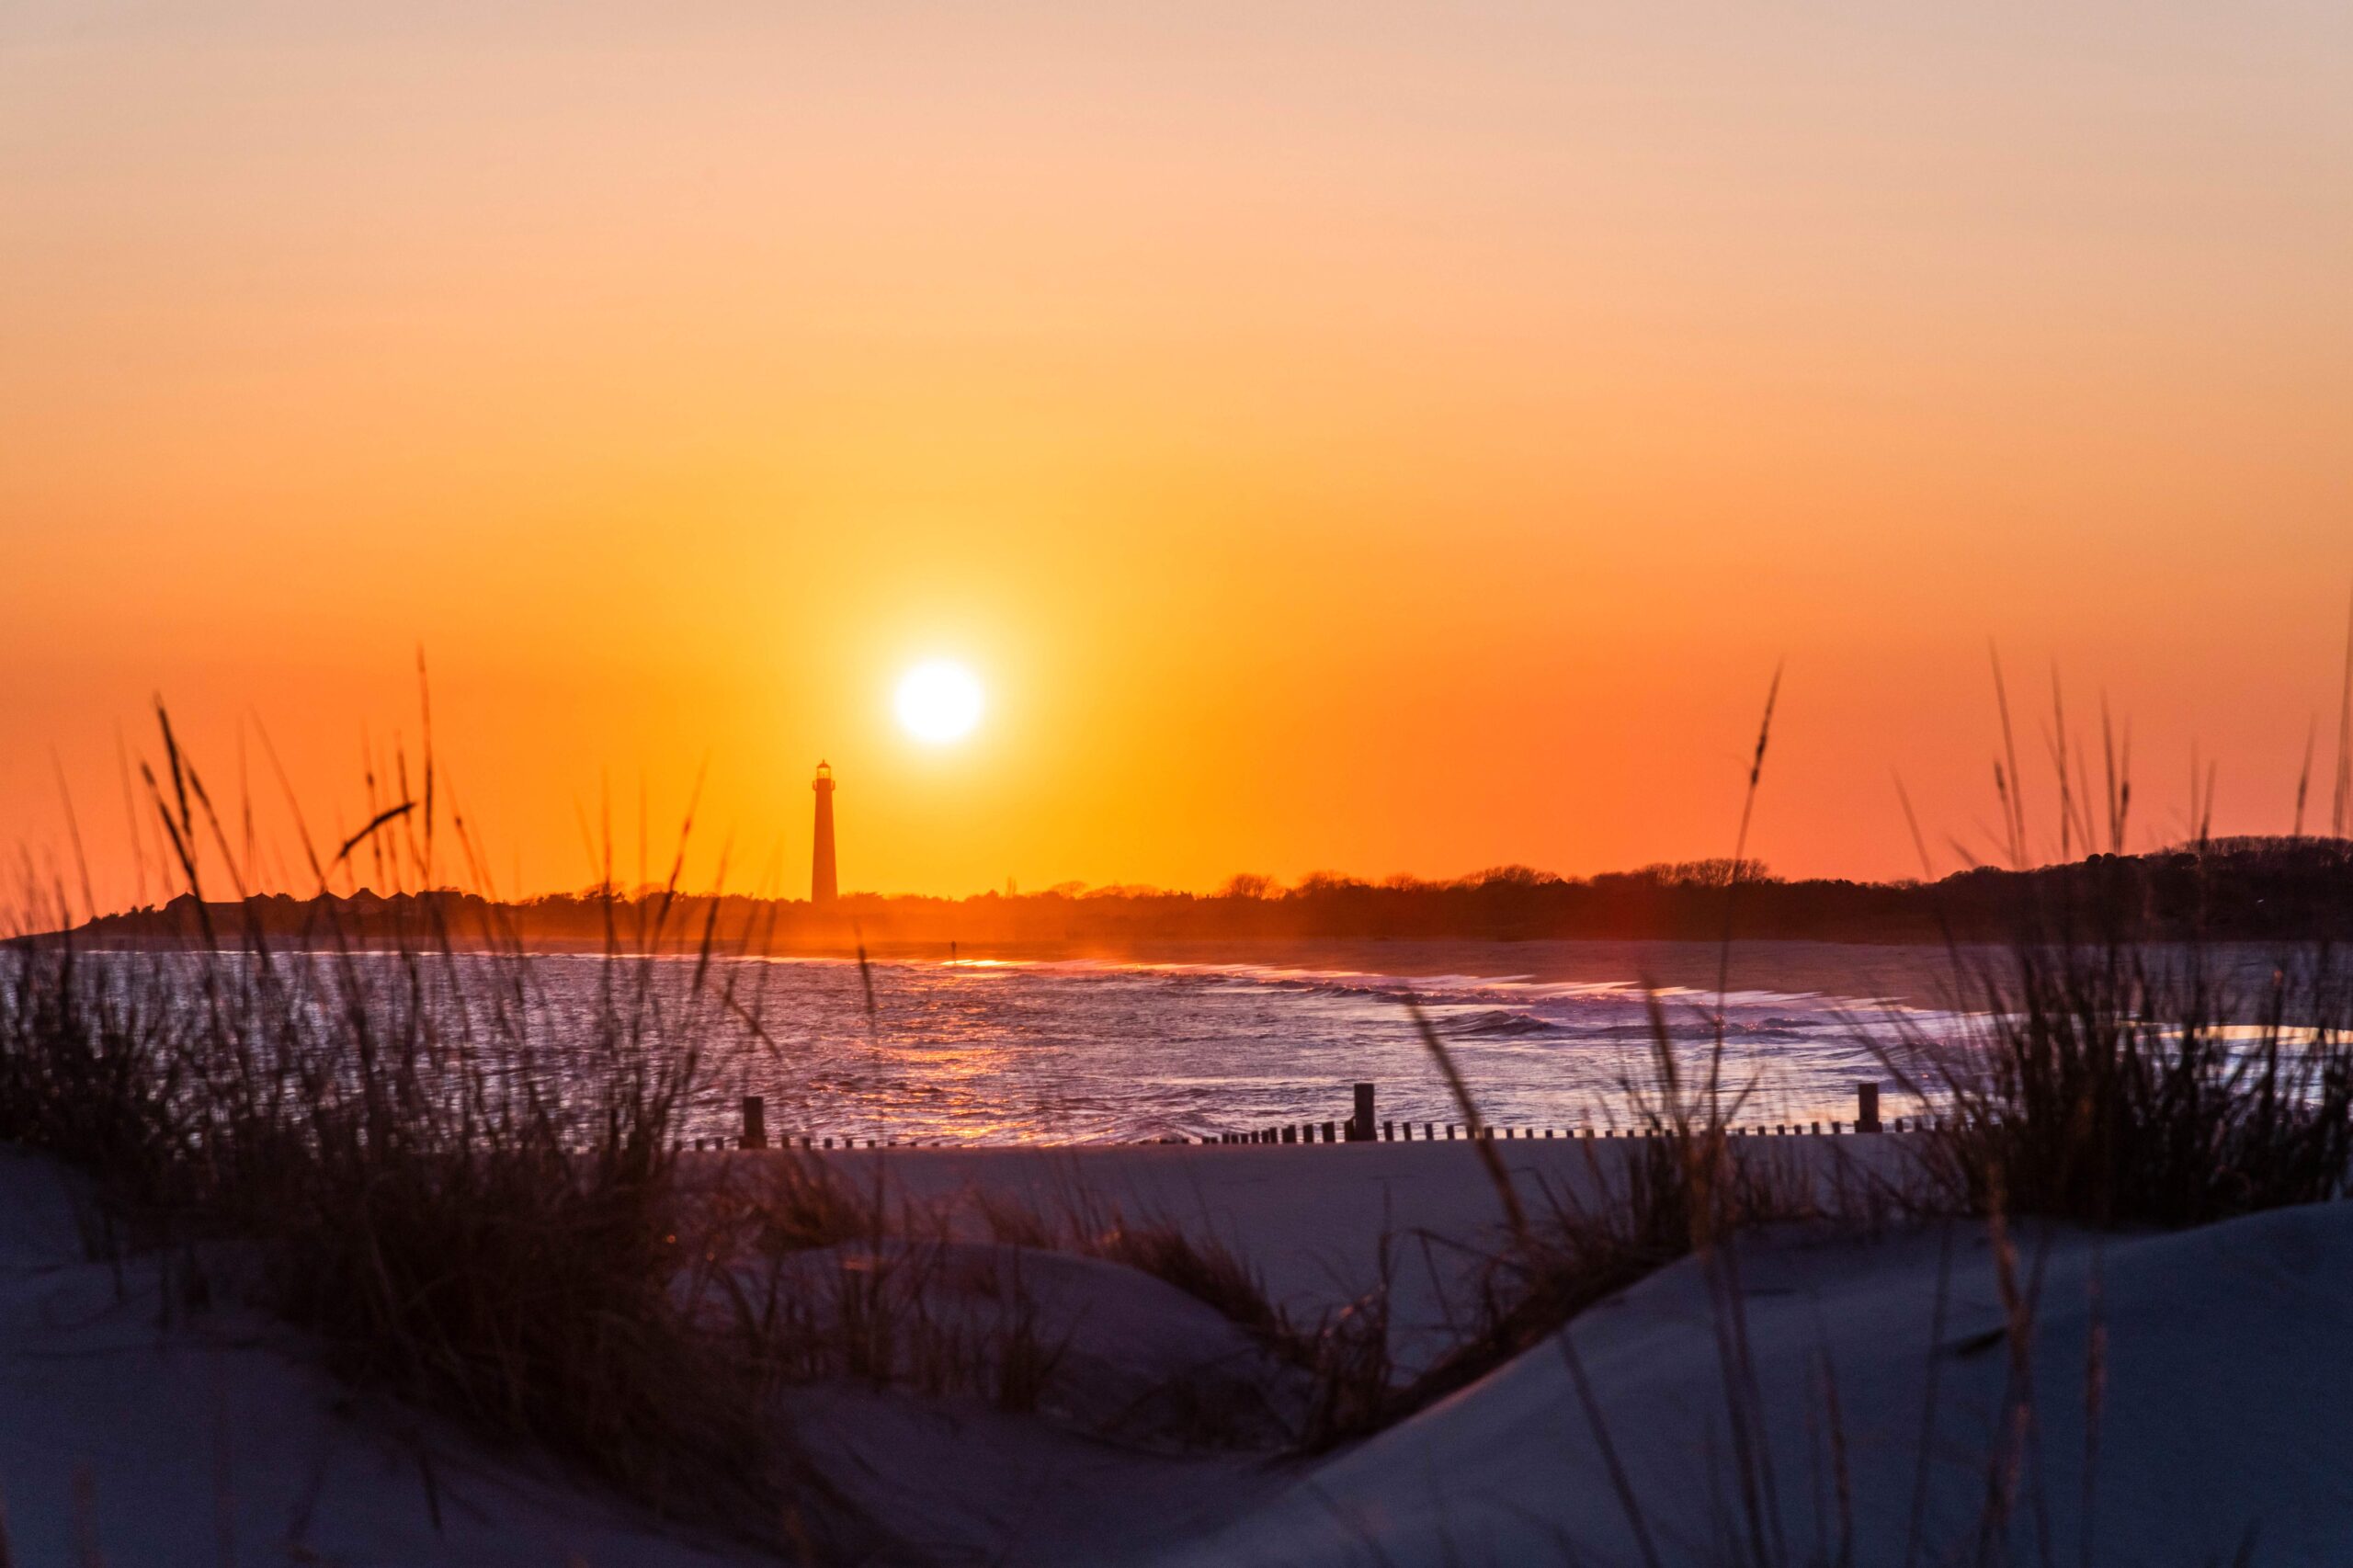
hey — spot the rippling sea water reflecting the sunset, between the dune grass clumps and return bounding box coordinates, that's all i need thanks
[635,944,1972,1144]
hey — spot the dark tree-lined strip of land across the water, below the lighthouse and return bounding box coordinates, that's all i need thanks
[47,838,2353,984]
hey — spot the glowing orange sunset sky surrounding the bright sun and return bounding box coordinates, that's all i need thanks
[0,0,2353,906]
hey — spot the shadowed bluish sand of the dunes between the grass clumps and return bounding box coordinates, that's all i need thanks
[14,1137,2353,1568]
